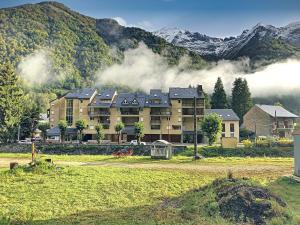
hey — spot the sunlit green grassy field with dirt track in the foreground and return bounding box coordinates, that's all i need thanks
[0,154,300,225]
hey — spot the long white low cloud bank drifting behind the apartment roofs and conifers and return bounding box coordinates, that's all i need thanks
[96,43,300,96]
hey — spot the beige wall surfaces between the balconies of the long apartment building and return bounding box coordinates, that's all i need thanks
[50,94,204,142]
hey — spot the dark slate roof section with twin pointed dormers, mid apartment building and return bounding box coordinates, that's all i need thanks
[115,93,146,108]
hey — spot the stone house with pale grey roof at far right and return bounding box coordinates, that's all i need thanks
[243,104,298,138]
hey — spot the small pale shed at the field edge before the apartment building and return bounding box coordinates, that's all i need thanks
[151,140,173,159]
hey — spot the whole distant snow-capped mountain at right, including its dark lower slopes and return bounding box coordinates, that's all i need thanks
[154,22,300,60]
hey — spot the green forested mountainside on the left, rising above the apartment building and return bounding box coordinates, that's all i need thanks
[0,2,206,89]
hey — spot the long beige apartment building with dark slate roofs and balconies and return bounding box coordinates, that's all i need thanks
[48,85,204,142]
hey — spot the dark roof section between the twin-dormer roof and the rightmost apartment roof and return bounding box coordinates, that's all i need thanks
[145,89,170,107]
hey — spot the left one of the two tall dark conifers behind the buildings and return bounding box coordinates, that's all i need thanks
[211,77,228,109]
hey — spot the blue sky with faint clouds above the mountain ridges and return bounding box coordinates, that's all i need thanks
[0,0,300,37]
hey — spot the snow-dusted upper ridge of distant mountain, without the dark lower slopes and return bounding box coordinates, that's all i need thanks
[154,22,300,58]
